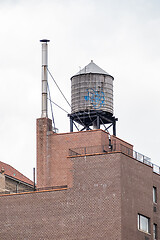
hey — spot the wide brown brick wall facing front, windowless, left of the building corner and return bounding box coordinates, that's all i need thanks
[0,153,122,240]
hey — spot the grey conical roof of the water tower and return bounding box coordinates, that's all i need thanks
[72,60,111,77]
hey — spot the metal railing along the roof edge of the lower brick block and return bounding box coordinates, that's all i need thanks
[69,144,160,175]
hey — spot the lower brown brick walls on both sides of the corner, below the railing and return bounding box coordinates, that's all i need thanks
[0,153,160,240]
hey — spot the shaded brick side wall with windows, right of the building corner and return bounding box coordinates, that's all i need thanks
[121,155,160,240]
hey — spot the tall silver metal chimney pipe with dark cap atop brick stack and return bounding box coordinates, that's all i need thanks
[40,39,50,118]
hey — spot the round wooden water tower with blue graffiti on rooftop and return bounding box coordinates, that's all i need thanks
[69,61,118,135]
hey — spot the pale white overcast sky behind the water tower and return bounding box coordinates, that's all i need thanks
[0,0,160,178]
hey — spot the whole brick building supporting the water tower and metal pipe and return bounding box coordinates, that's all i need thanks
[0,118,160,240]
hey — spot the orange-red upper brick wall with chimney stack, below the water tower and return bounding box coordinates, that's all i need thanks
[37,118,111,188]
